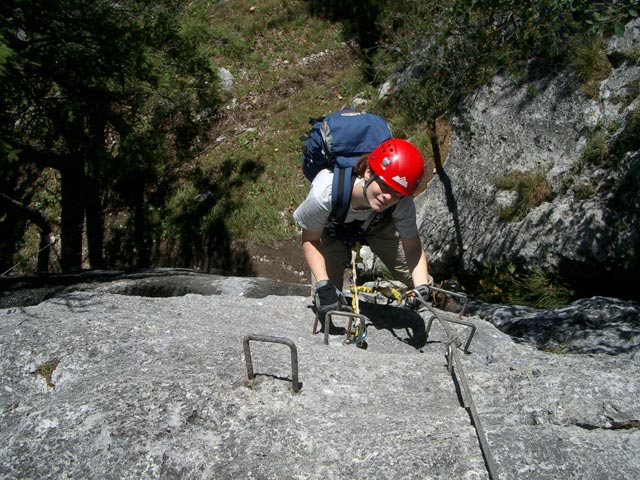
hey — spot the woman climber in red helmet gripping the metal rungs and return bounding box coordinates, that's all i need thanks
[293,138,432,326]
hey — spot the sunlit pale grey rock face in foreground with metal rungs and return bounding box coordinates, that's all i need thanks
[0,272,640,480]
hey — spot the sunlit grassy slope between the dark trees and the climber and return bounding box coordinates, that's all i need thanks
[200,0,367,242]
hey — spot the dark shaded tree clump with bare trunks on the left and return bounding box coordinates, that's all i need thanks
[0,0,219,271]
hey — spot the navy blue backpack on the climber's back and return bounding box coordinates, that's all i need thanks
[302,110,392,223]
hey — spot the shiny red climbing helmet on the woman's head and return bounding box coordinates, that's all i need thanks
[369,138,424,195]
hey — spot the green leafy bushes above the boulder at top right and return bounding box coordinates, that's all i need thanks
[381,0,640,126]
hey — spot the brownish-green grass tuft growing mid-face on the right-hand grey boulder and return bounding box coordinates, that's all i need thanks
[495,169,553,222]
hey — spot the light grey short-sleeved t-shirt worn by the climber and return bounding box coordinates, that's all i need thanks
[293,169,418,238]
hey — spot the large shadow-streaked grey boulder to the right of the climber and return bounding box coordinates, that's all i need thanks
[417,21,640,298]
